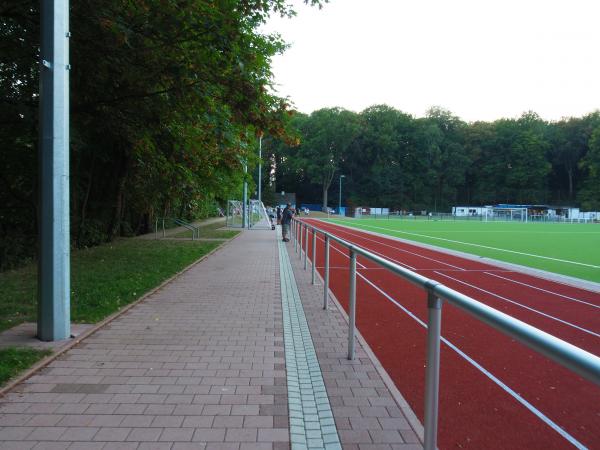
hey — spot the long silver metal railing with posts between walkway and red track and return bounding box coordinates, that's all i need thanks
[291,219,600,450]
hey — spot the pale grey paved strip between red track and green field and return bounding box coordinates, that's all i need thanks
[315,218,600,293]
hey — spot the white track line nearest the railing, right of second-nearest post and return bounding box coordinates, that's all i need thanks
[358,274,587,450]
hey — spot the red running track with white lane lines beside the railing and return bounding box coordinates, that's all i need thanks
[296,219,600,450]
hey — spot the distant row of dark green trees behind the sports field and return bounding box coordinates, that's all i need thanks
[269,105,600,211]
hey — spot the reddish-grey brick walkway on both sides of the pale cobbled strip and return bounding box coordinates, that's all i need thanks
[0,230,421,450]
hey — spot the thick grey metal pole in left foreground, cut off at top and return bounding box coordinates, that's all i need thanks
[37,0,71,341]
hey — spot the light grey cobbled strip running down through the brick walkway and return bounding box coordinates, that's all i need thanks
[279,237,342,450]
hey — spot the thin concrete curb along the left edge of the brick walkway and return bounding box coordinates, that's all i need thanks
[0,233,242,398]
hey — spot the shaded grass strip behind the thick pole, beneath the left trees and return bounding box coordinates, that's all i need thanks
[0,239,221,331]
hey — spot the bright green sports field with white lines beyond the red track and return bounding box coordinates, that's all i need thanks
[331,218,600,282]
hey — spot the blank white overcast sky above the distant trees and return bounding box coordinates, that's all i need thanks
[265,0,600,121]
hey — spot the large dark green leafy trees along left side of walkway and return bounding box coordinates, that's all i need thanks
[0,0,326,270]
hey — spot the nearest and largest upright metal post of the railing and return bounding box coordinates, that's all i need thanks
[424,290,442,450]
